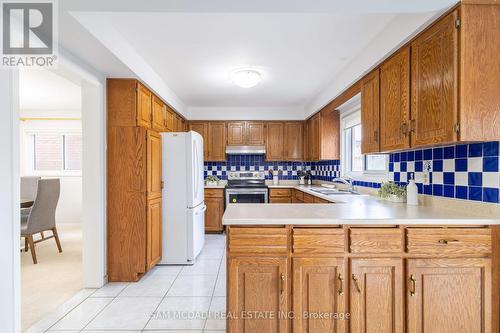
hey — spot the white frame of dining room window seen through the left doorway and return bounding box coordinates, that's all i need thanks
[23,128,83,177]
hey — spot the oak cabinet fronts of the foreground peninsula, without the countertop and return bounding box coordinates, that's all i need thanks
[227,225,500,333]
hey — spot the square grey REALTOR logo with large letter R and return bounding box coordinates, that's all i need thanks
[2,1,57,68]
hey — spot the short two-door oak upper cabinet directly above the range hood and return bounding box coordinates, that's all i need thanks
[227,121,265,146]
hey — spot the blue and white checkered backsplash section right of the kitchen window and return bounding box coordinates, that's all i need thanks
[389,141,500,203]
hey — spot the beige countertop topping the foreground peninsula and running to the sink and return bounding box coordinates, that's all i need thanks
[222,185,500,225]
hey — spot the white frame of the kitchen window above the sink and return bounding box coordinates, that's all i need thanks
[340,105,389,182]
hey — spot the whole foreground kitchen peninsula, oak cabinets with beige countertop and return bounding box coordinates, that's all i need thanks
[223,194,500,333]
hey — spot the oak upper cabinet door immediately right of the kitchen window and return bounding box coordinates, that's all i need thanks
[361,68,380,154]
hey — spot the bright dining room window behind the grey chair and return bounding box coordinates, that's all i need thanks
[26,131,82,174]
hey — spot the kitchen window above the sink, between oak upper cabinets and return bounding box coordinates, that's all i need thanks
[341,107,388,180]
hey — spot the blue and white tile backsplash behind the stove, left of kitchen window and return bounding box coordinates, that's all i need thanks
[205,155,340,180]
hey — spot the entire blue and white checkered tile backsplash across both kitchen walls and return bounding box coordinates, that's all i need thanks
[205,141,500,203]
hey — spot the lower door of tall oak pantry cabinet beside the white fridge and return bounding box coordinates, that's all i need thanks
[146,198,162,270]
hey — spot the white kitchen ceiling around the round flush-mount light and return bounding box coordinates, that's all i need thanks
[56,0,455,119]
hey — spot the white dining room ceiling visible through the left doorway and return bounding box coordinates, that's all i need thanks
[19,70,82,113]
